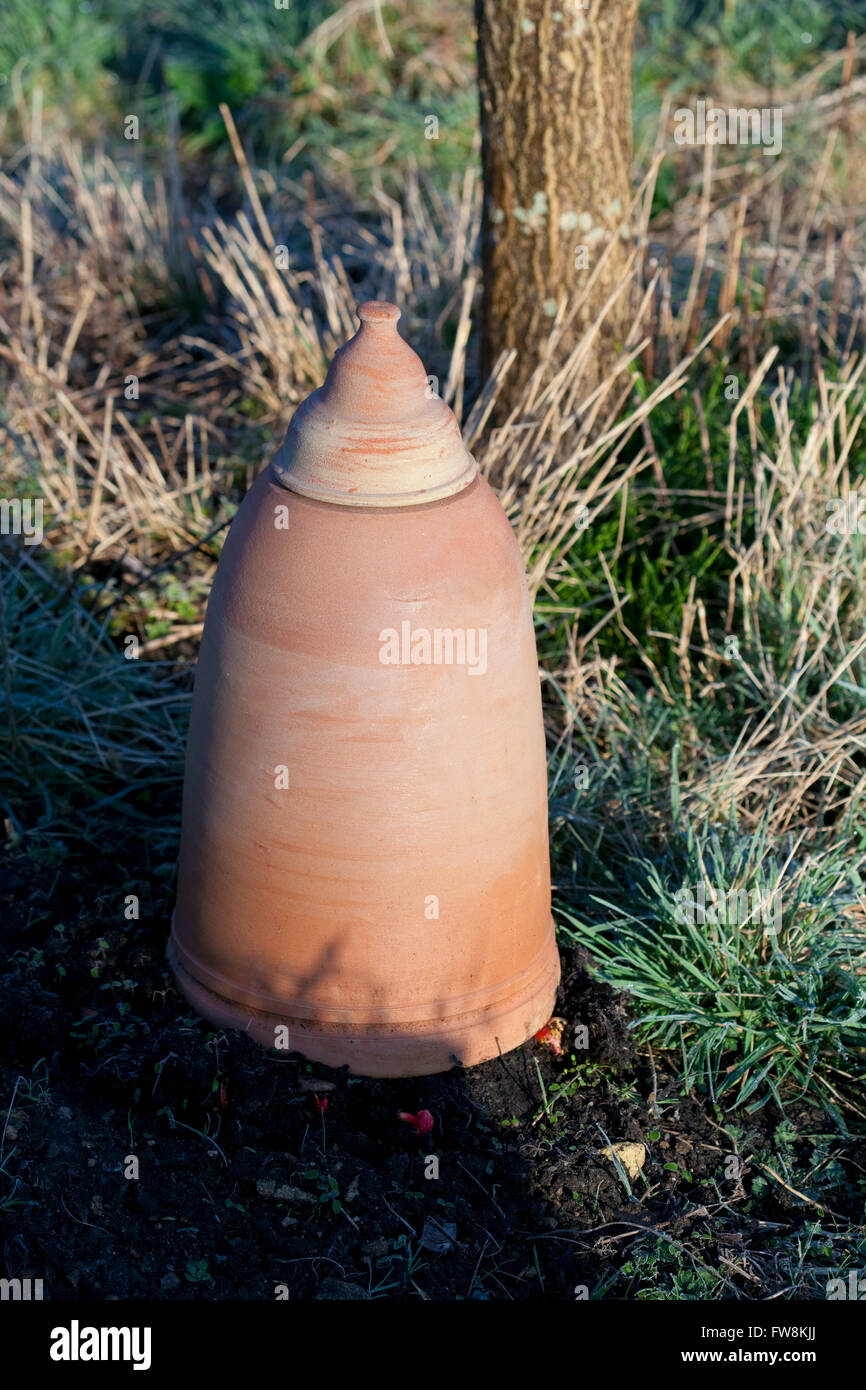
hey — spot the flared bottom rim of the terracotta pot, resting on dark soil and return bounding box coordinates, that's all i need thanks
[165,922,560,1077]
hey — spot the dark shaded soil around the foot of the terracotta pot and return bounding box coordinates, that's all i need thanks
[0,817,863,1300]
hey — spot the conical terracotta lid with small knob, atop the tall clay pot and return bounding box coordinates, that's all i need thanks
[271,299,478,507]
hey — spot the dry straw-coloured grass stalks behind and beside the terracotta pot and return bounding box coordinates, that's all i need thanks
[0,81,866,856]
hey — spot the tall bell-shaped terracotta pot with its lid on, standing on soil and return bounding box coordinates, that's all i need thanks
[168,302,559,1076]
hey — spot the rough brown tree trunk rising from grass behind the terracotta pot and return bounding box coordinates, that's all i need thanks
[475,0,638,420]
